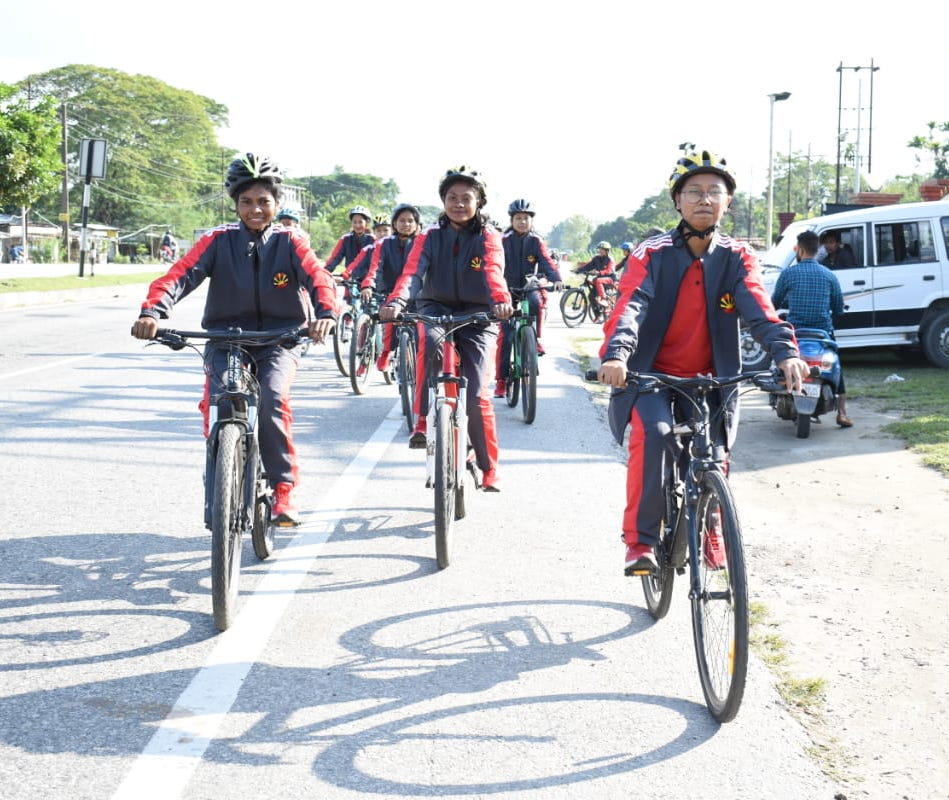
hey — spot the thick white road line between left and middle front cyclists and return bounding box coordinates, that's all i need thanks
[113,403,402,800]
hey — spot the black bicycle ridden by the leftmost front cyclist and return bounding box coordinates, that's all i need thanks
[151,328,307,631]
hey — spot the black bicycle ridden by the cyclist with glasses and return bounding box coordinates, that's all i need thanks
[587,371,773,722]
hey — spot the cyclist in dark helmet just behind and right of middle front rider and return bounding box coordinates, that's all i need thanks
[494,198,563,397]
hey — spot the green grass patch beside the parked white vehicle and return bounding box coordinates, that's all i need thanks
[843,350,949,476]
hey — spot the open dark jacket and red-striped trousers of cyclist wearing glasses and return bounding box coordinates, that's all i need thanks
[600,230,798,544]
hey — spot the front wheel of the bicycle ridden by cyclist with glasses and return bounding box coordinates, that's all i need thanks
[692,470,748,722]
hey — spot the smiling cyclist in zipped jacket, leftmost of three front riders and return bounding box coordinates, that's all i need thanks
[132,153,338,525]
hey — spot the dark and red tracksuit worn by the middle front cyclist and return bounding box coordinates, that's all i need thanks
[388,220,511,470]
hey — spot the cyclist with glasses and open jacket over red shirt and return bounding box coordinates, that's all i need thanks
[599,151,808,575]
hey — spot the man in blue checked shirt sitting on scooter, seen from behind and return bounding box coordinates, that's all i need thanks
[771,231,853,428]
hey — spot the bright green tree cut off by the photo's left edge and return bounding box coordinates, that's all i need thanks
[0,84,62,208]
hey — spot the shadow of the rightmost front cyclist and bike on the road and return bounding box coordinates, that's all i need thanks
[0,599,718,796]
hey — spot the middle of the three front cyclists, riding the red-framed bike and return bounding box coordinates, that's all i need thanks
[380,167,514,491]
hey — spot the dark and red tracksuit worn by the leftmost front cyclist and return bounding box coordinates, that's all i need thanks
[141,222,338,486]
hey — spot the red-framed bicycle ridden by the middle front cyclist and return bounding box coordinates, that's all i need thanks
[402,311,496,569]
